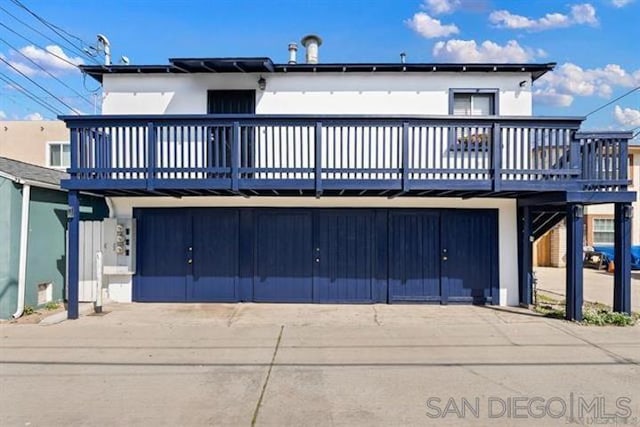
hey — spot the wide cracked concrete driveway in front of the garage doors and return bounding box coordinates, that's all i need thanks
[0,304,640,426]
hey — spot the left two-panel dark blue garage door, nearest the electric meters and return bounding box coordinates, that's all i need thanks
[134,209,239,302]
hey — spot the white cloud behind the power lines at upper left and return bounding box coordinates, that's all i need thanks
[1,45,84,76]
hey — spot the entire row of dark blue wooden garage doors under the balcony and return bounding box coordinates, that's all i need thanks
[134,208,498,304]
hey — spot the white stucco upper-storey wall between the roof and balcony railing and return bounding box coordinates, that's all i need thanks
[102,72,532,116]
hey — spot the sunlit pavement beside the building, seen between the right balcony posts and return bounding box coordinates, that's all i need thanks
[534,267,640,312]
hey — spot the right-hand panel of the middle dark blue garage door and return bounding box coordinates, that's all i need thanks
[314,211,374,302]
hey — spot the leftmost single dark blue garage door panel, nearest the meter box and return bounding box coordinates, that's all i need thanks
[134,209,190,302]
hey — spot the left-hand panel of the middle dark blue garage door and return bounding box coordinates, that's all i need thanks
[253,210,313,302]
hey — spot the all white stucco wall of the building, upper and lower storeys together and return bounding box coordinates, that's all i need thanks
[97,72,532,305]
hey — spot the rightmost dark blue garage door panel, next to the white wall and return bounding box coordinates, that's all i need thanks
[442,210,497,304]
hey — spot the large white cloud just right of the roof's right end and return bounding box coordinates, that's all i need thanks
[534,62,640,107]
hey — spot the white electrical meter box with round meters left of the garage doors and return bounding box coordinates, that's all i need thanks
[102,218,136,275]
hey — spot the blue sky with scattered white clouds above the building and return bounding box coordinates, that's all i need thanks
[0,0,640,135]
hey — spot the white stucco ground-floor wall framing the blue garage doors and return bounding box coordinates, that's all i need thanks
[102,197,518,305]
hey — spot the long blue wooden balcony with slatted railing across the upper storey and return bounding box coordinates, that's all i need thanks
[62,115,631,197]
